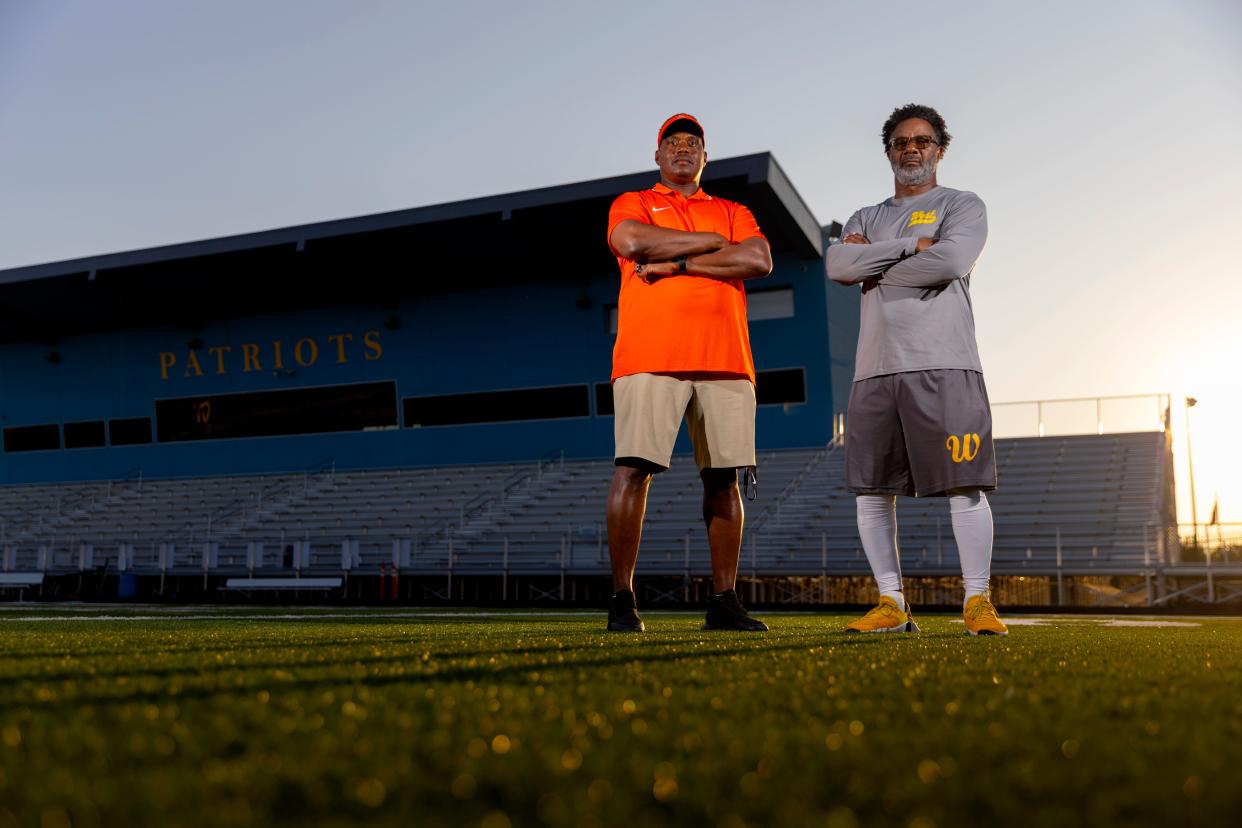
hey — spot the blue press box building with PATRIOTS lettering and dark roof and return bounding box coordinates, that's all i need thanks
[0,153,858,484]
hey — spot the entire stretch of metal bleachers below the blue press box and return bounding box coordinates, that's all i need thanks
[0,432,1166,576]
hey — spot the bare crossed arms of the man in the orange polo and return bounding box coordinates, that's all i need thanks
[609,218,773,284]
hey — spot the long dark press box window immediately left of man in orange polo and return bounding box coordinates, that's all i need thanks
[401,385,591,428]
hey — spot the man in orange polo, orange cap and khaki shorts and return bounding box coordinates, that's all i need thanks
[607,113,773,632]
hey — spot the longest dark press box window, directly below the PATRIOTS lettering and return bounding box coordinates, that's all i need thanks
[155,381,397,443]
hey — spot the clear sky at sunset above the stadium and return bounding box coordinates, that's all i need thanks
[0,0,1242,521]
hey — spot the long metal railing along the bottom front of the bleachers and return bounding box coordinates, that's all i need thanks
[9,525,1242,606]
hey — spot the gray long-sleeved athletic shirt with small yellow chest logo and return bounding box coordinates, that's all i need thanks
[825,186,987,381]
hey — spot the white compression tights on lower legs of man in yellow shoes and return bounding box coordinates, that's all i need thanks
[856,490,992,608]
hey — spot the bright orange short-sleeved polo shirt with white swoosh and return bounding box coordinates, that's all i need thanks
[609,184,764,382]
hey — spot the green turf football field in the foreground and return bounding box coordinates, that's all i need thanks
[0,605,1242,828]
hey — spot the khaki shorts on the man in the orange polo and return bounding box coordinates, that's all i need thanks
[612,374,755,469]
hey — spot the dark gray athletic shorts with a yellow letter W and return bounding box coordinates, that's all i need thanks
[846,370,996,498]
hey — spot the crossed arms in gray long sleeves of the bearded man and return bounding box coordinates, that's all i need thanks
[825,197,987,288]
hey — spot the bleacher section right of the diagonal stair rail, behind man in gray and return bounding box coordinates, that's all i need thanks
[760,432,1164,574]
